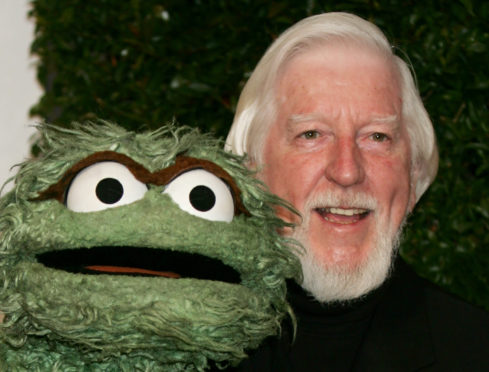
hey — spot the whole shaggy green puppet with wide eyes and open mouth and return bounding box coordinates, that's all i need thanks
[0,122,301,372]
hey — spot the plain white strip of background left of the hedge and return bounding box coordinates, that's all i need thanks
[0,0,42,192]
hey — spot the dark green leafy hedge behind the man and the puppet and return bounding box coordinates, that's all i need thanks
[31,0,489,309]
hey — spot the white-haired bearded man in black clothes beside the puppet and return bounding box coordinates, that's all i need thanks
[226,13,489,371]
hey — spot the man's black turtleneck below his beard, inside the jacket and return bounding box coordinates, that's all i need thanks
[231,258,398,372]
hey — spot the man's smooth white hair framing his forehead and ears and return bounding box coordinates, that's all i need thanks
[226,13,438,201]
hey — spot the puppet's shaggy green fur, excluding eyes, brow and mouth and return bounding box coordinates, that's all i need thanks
[0,123,300,371]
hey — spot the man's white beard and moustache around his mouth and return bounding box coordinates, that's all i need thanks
[292,190,405,303]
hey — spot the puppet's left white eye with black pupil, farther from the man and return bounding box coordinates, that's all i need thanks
[66,161,148,212]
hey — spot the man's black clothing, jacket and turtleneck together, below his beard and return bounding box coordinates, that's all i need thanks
[231,259,489,372]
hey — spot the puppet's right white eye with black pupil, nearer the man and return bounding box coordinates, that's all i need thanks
[164,169,234,222]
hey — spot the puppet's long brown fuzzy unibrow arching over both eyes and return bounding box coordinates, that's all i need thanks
[33,151,250,216]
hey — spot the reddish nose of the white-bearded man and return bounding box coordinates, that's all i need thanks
[325,138,365,187]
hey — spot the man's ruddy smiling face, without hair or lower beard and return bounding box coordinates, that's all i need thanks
[261,44,415,300]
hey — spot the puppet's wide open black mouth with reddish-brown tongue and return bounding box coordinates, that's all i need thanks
[37,246,241,284]
